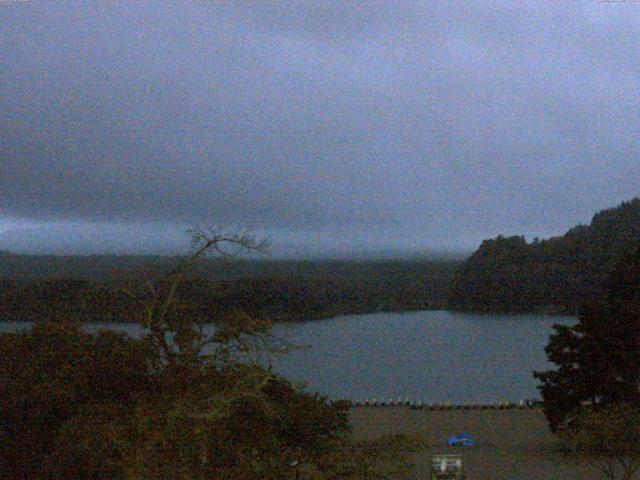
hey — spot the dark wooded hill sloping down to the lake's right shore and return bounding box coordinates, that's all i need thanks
[449,198,640,315]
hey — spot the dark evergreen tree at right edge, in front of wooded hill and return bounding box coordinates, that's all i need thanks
[535,248,640,431]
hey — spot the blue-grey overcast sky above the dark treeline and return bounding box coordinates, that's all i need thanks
[0,0,640,255]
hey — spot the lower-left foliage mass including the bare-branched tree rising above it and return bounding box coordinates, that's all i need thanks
[0,231,428,480]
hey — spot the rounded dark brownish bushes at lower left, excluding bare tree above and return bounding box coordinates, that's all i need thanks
[0,322,356,479]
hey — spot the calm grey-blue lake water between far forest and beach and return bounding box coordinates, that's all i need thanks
[0,311,576,403]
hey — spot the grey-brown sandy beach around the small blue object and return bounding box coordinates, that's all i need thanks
[351,407,601,480]
